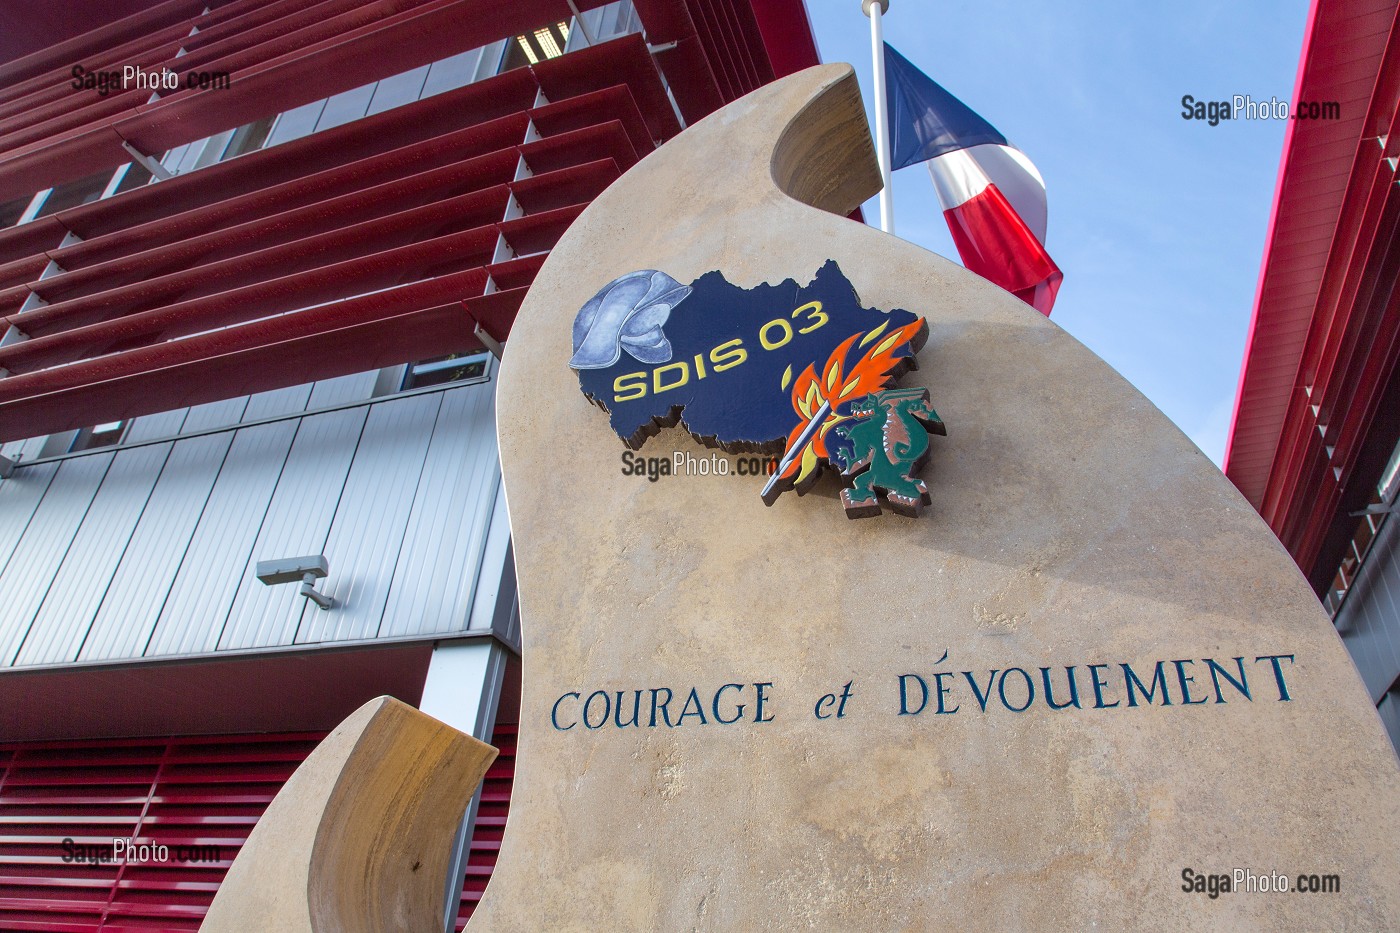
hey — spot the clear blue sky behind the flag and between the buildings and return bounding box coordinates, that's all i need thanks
[806,0,1308,464]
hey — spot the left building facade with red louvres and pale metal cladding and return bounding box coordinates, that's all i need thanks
[0,0,818,930]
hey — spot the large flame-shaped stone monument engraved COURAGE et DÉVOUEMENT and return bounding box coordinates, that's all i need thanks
[469,66,1400,930]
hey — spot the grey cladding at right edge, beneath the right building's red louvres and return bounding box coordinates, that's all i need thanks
[1337,516,1400,702]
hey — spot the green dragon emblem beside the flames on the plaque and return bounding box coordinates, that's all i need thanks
[830,388,948,518]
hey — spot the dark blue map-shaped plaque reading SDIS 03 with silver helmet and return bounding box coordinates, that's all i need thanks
[571,261,924,454]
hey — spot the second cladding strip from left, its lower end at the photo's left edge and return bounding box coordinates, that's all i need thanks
[0,454,112,665]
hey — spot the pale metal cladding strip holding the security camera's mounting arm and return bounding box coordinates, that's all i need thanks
[297,392,442,643]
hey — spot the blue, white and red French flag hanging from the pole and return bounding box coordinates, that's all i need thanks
[885,42,1064,317]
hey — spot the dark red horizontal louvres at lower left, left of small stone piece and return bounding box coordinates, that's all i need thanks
[0,733,322,933]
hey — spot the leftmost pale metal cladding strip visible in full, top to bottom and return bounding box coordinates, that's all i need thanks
[14,444,172,667]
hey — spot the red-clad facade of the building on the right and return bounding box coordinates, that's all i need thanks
[1225,0,1400,747]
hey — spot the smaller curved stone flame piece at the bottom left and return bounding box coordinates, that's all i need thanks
[199,696,496,933]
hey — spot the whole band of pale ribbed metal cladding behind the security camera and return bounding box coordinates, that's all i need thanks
[0,380,500,665]
